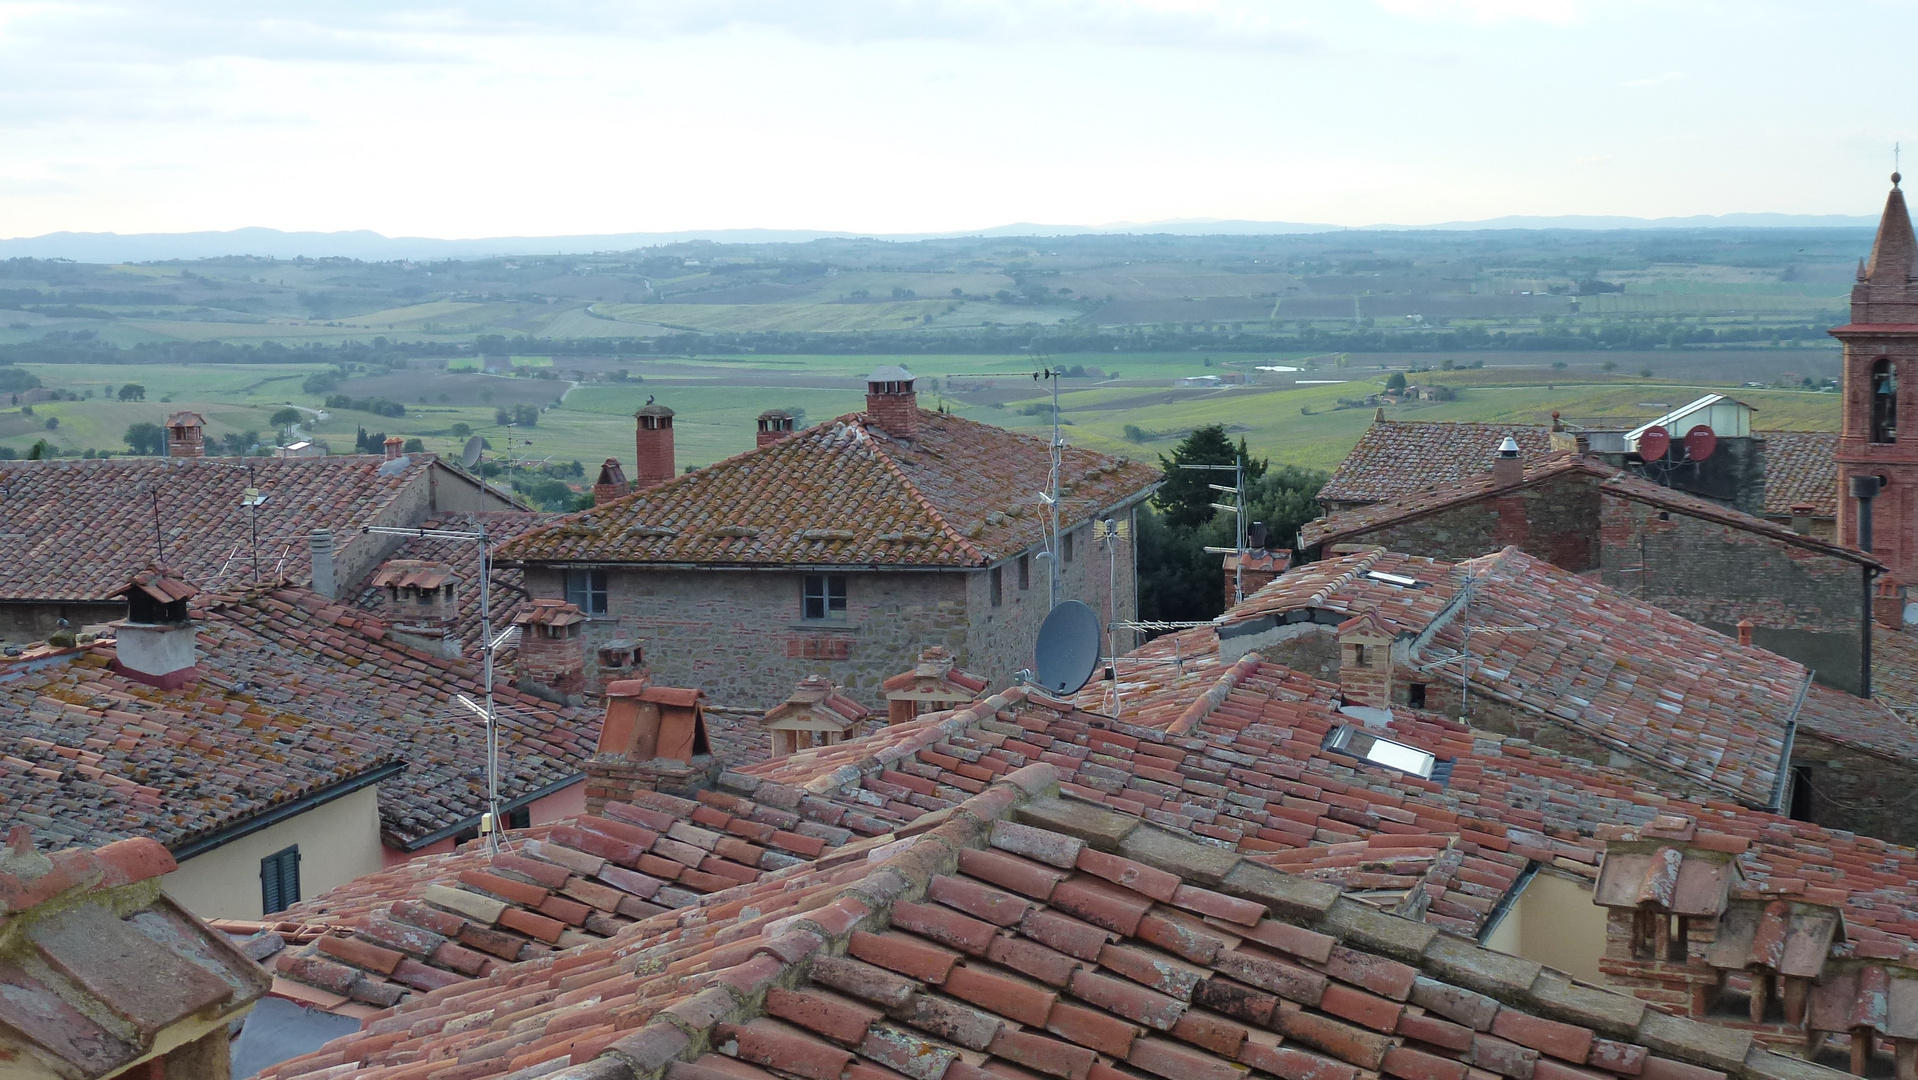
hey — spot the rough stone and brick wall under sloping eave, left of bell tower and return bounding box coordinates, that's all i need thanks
[1600,497,1864,693]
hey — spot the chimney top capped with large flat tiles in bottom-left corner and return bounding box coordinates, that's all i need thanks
[0,825,267,1078]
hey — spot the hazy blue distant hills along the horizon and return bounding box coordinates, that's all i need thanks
[0,213,1878,263]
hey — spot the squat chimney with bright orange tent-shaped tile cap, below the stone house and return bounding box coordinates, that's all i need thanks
[587,679,717,813]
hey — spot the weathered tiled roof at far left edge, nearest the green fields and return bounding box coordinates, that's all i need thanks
[0,455,443,600]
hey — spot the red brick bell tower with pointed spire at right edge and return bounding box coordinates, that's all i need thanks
[1832,173,1918,583]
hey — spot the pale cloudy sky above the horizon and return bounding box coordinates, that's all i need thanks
[0,0,1918,238]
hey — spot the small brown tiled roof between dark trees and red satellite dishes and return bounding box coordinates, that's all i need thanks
[1320,420,1552,503]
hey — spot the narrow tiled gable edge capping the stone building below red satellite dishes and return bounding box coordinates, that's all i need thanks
[1298,453,1882,566]
